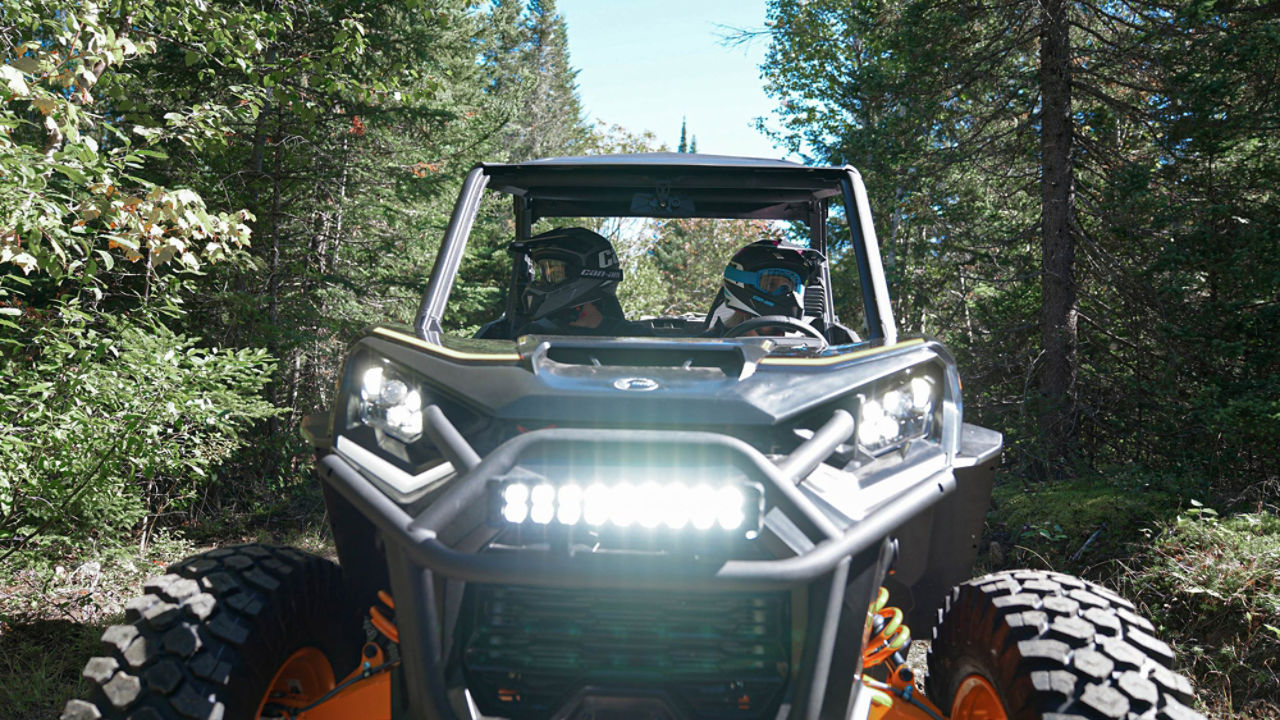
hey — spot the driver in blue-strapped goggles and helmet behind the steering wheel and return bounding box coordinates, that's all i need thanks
[704,240,823,336]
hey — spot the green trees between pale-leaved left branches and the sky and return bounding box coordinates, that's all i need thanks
[129,1,585,407]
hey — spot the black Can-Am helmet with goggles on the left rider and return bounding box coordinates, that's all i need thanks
[511,228,622,320]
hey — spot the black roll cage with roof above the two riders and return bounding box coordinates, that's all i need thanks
[413,152,897,343]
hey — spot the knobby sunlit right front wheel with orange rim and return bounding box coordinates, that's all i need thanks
[925,570,1204,720]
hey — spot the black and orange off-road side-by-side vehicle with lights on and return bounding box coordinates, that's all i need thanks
[64,154,1199,720]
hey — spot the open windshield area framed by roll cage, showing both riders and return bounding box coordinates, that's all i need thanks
[444,193,865,343]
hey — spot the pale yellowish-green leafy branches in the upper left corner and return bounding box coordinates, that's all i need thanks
[0,0,262,282]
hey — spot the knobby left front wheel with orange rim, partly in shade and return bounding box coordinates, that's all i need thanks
[63,544,364,720]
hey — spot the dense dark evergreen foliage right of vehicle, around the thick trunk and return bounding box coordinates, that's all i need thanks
[763,0,1280,489]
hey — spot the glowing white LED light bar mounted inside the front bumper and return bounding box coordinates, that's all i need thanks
[490,480,764,537]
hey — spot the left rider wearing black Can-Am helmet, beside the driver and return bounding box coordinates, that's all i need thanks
[511,228,640,336]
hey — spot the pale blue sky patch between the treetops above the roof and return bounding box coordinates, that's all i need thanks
[556,0,782,158]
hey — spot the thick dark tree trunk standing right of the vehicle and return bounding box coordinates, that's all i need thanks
[1039,0,1078,477]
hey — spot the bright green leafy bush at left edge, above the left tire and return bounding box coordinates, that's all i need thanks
[0,305,276,547]
